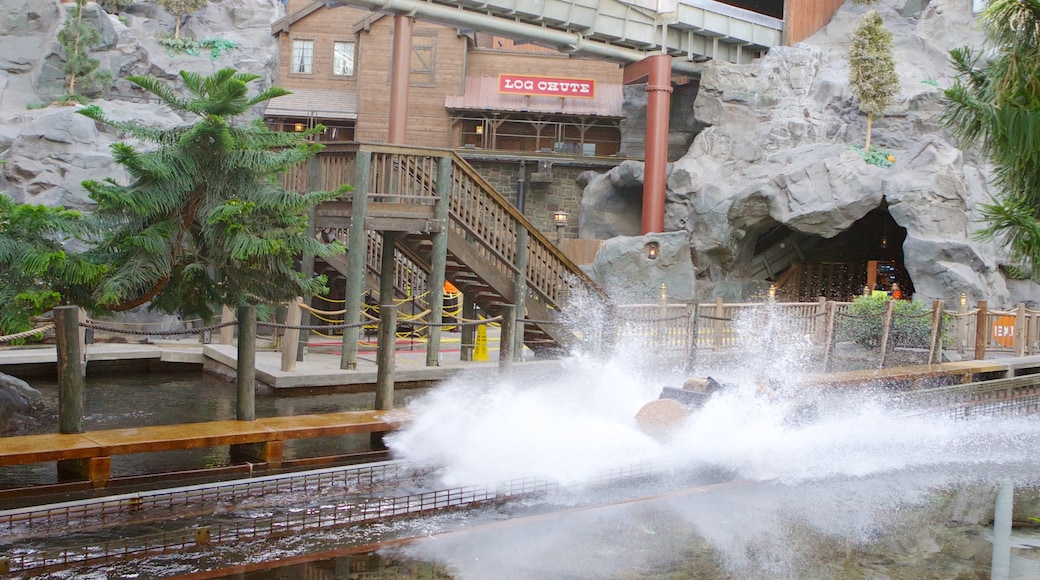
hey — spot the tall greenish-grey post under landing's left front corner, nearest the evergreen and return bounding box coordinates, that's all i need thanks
[339,151,372,370]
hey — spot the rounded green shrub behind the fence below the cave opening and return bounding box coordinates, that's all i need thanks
[837,296,932,348]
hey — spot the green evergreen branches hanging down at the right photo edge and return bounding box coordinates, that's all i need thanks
[941,0,1040,268]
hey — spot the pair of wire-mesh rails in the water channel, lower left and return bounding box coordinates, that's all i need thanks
[0,462,660,574]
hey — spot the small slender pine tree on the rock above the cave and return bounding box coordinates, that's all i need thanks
[849,8,900,152]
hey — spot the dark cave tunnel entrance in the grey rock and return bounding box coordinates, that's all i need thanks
[754,203,914,301]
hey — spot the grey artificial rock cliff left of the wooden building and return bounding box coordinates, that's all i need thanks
[0,0,284,209]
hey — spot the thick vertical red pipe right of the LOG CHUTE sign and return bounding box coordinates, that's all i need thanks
[643,54,672,234]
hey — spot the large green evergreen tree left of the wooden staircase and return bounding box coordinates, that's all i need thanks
[80,69,349,319]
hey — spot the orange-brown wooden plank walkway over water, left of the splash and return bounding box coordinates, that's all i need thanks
[0,411,398,487]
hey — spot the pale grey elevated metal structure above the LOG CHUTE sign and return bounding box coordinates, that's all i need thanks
[326,0,784,68]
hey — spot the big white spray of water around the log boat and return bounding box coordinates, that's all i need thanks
[387,305,1040,485]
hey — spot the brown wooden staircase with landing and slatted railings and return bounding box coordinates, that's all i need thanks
[284,143,606,351]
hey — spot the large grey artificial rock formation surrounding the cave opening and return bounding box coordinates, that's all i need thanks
[581,0,1023,307]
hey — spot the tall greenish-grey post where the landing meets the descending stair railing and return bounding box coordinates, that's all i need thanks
[426,157,451,367]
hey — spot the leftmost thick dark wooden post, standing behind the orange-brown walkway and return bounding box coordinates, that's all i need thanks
[54,306,86,433]
